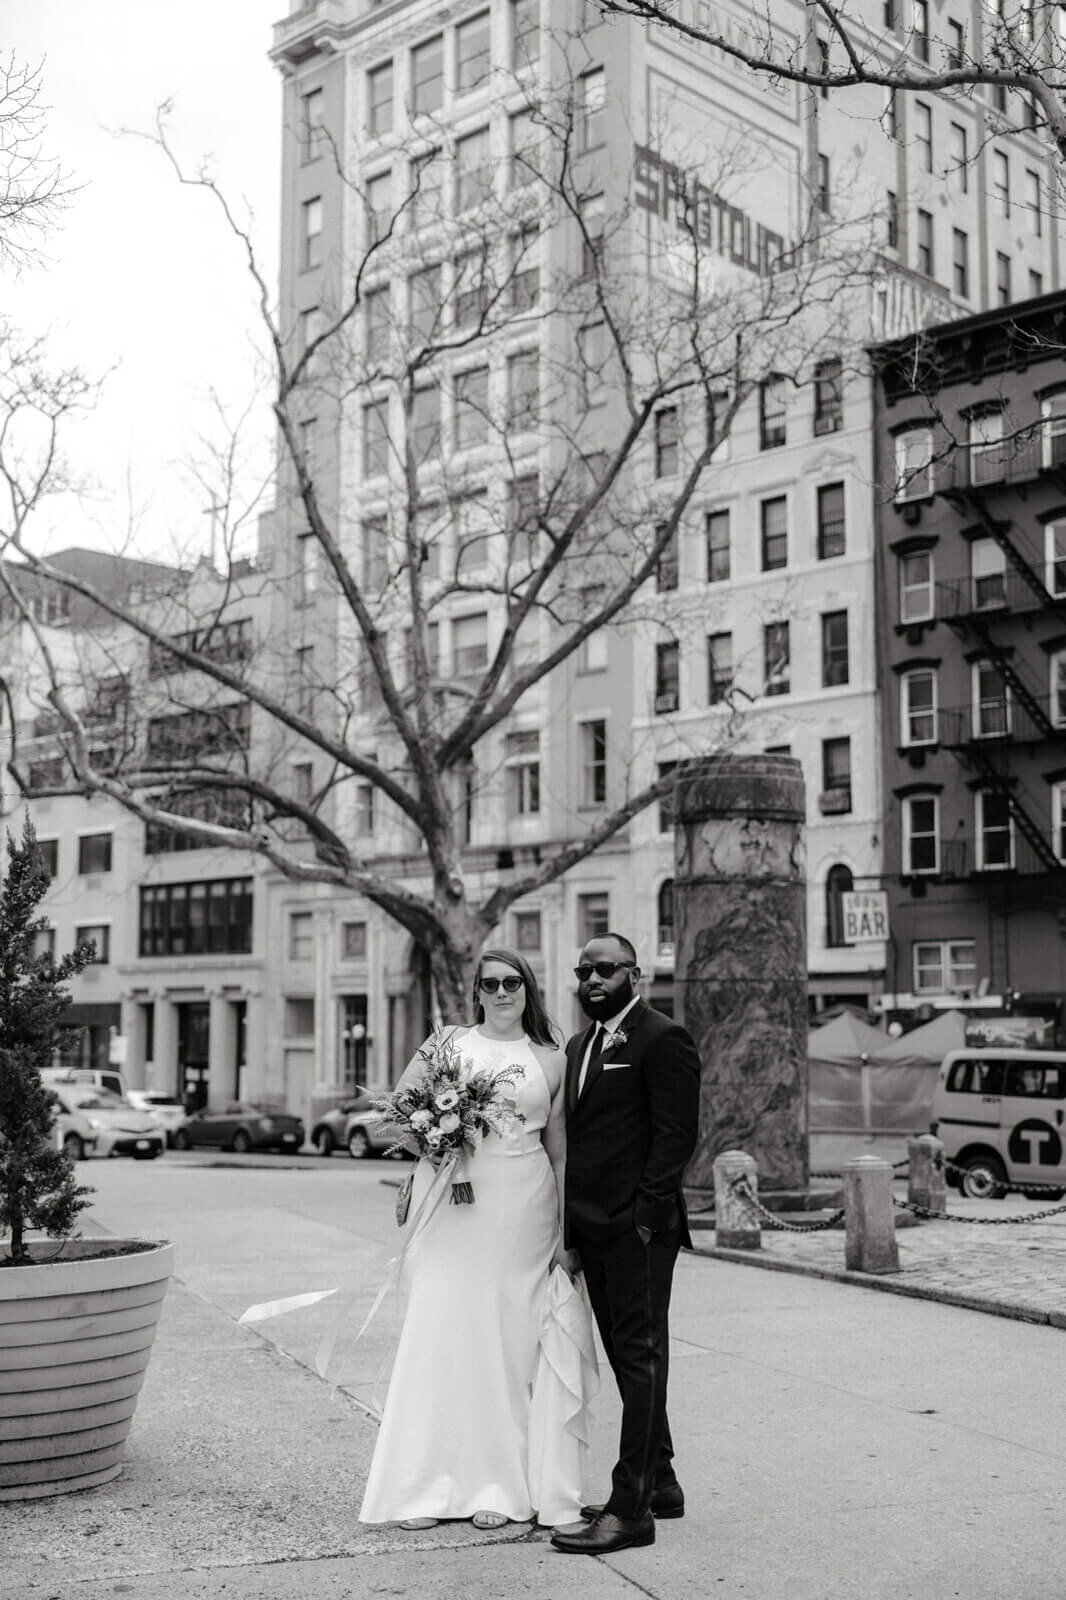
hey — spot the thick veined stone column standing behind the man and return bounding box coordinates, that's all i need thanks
[674,755,808,1197]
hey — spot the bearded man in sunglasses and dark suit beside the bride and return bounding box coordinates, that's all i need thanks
[552,933,699,1555]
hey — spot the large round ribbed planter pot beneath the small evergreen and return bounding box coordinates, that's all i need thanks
[0,1238,174,1501]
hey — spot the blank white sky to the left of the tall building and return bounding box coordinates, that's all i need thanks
[0,0,288,557]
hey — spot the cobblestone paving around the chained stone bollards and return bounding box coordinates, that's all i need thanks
[693,1186,1066,1328]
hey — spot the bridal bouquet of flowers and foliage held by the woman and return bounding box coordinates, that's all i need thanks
[375,1027,525,1205]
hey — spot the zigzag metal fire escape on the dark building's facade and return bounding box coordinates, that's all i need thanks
[938,426,1066,877]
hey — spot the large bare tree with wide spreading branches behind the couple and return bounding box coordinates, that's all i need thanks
[0,56,871,1014]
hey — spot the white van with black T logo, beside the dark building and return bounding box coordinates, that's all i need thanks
[930,1048,1066,1200]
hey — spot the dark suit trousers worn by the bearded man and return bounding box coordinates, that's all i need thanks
[575,1227,680,1518]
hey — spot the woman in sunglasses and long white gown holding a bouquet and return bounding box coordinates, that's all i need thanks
[359,950,576,1528]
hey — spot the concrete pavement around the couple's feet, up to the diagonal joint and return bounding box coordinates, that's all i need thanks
[10,1190,1066,1600]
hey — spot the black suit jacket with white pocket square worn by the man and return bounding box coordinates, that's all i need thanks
[565,1000,699,1246]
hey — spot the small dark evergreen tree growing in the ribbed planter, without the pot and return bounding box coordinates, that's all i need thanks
[0,816,93,1267]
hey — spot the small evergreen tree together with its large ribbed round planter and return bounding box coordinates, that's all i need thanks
[0,819,174,1501]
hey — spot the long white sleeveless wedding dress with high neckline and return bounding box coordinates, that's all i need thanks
[359,1029,594,1523]
